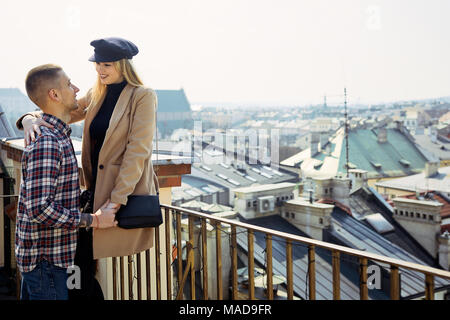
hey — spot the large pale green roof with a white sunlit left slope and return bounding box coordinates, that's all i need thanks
[281,128,426,178]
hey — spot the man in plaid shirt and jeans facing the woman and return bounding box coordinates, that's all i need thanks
[15,64,117,300]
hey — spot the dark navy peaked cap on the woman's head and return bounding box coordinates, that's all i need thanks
[89,37,139,62]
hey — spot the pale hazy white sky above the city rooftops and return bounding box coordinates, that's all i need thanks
[0,0,450,105]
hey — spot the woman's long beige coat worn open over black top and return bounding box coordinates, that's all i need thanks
[71,84,157,259]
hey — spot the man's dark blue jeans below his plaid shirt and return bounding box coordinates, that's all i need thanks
[20,260,69,300]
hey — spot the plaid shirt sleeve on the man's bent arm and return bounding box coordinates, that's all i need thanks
[24,135,80,229]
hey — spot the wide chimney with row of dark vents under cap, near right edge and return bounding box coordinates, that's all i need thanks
[393,198,443,258]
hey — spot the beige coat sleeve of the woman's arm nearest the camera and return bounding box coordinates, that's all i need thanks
[111,89,157,205]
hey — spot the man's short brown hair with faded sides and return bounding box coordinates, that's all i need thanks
[25,64,62,107]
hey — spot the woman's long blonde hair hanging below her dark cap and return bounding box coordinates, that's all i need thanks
[89,59,144,108]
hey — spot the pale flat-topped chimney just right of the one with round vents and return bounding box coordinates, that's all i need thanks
[281,198,334,241]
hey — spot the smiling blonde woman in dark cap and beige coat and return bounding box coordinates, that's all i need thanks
[18,38,157,299]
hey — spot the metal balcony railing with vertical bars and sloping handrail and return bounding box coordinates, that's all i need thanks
[113,205,450,300]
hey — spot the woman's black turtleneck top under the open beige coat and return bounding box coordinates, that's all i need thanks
[89,80,127,191]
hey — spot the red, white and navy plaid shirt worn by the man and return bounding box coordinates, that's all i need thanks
[15,113,81,272]
